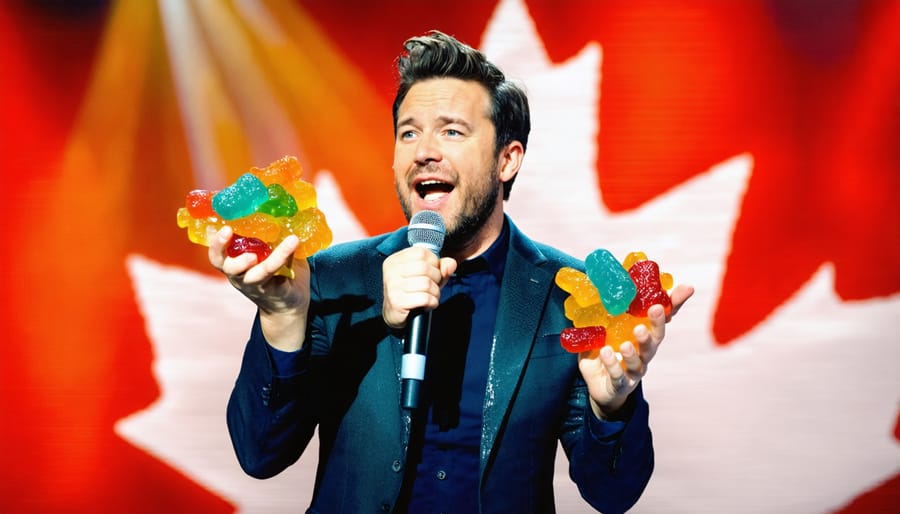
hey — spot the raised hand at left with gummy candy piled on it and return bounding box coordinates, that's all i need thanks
[208,226,309,351]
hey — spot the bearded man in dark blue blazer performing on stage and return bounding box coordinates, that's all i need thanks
[210,32,693,514]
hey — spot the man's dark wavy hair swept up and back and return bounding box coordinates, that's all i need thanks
[393,30,531,200]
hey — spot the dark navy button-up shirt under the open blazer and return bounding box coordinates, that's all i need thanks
[398,225,509,514]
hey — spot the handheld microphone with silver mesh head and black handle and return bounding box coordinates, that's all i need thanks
[400,211,447,409]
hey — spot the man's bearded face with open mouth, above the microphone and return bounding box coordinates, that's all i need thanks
[393,78,502,248]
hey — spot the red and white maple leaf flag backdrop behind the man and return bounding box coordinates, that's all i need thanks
[0,0,900,514]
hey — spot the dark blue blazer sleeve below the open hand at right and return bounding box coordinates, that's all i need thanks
[562,377,654,514]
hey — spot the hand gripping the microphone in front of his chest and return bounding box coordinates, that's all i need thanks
[382,246,456,330]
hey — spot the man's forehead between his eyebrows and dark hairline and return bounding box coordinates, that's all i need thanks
[397,78,490,123]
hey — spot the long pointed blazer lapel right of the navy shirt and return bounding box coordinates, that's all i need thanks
[481,221,553,466]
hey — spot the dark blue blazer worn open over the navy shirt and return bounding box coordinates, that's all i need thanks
[227,219,653,514]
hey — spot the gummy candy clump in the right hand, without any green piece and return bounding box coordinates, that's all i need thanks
[556,248,673,353]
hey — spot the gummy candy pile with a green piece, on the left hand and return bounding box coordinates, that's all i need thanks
[178,156,332,268]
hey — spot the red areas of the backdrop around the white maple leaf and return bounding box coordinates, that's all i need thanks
[0,0,900,512]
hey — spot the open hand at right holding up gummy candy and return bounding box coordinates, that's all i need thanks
[578,285,694,419]
